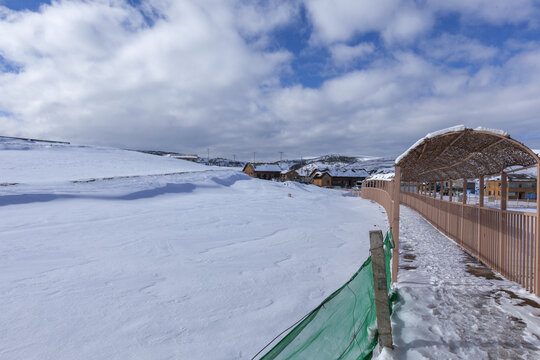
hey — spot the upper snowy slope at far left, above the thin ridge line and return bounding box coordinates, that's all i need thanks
[0,137,209,184]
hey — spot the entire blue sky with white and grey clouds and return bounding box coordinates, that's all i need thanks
[0,0,540,160]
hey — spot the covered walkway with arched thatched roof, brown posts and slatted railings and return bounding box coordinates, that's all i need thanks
[362,126,540,296]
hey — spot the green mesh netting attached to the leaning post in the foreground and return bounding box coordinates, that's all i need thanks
[261,231,393,360]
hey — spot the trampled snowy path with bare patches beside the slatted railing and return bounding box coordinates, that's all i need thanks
[390,206,540,359]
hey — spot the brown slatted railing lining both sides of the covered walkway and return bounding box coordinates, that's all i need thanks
[362,181,540,295]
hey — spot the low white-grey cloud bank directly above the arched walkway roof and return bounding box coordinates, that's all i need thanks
[268,50,540,155]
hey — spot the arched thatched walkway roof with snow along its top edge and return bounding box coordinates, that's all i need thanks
[396,126,540,181]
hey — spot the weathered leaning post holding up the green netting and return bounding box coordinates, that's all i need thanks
[369,230,394,349]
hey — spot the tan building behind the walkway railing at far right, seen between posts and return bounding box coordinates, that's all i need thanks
[486,174,537,199]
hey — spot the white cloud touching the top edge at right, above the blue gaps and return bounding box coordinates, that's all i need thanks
[304,0,540,46]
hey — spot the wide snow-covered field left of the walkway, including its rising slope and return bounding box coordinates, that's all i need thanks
[0,141,387,360]
